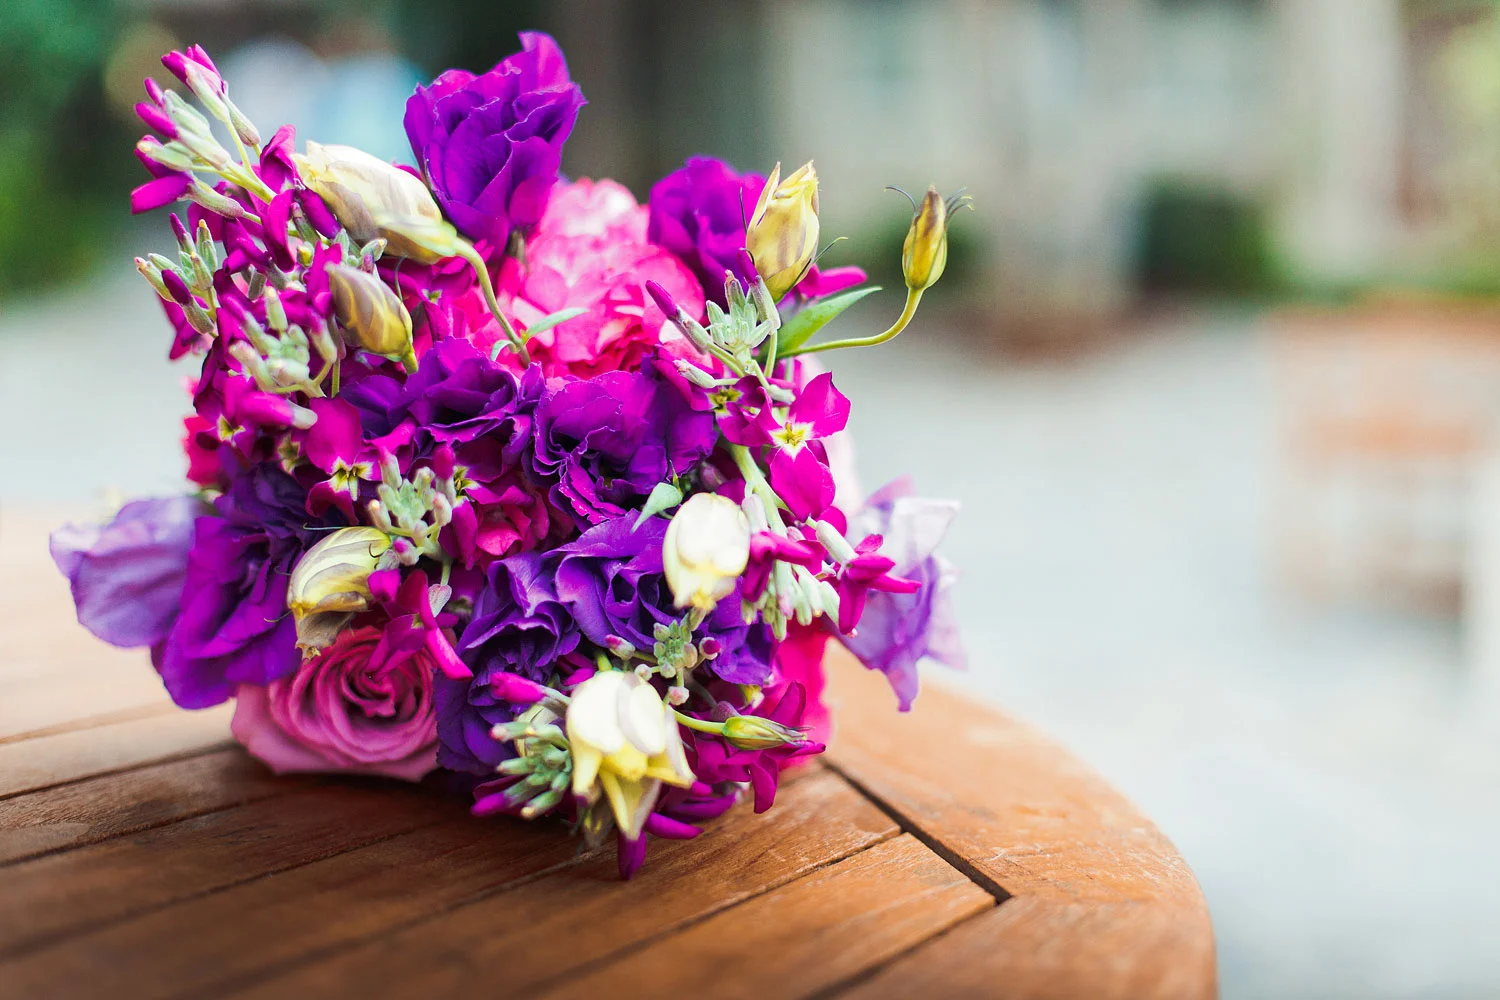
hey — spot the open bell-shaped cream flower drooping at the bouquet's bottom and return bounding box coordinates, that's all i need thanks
[567,670,695,840]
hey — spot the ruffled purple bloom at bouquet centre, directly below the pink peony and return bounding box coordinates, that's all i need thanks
[533,367,717,525]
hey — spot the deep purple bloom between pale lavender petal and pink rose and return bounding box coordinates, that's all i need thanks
[153,465,339,708]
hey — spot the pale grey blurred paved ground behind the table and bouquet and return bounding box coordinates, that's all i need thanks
[0,268,1500,997]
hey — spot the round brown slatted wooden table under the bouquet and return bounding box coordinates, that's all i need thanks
[0,519,1215,1000]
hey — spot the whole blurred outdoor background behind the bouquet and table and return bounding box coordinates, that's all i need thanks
[0,0,1500,997]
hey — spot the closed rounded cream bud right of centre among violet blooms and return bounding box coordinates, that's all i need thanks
[662,493,750,612]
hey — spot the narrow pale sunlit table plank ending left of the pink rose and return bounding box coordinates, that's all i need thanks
[0,705,234,798]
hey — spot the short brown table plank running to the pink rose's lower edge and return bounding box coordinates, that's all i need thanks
[0,747,309,864]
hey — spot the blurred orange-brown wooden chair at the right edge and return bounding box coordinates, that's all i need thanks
[1268,301,1500,615]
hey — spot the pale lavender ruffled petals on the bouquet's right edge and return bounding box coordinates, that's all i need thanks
[843,480,966,712]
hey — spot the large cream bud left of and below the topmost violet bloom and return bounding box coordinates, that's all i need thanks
[296,141,452,264]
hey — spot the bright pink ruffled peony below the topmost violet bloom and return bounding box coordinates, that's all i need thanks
[489,180,704,376]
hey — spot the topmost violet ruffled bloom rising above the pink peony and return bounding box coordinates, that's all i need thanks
[405,31,585,247]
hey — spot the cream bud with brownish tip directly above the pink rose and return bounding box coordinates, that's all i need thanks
[287,528,390,652]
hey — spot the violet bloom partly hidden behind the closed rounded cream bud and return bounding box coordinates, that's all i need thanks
[543,513,776,684]
